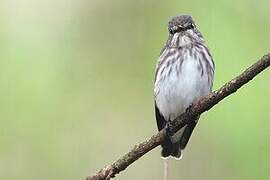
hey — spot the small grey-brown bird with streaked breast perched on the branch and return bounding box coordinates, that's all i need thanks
[154,15,215,159]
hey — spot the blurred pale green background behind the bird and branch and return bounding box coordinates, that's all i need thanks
[0,0,270,180]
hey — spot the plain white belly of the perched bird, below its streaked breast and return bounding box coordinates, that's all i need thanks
[155,57,211,120]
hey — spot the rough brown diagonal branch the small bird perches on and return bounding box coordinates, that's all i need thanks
[86,53,270,180]
